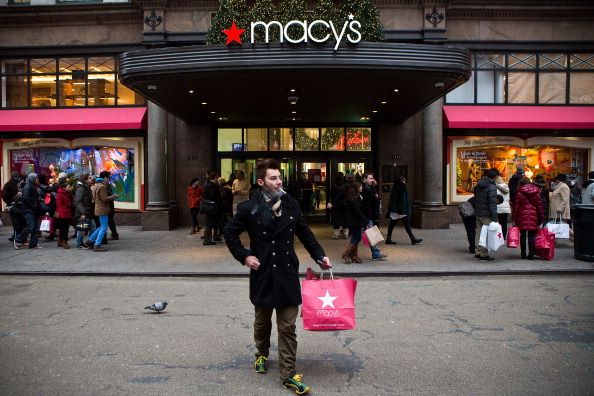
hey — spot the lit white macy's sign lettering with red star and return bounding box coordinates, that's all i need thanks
[223,14,362,51]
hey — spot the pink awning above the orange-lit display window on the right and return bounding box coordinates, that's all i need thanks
[443,106,594,129]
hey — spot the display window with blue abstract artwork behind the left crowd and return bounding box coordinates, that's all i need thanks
[3,138,143,210]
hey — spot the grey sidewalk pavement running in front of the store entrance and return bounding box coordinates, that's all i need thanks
[0,224,594,277]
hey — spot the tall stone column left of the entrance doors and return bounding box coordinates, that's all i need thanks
[141,101,174,231]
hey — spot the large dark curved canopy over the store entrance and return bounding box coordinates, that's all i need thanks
[119,43,470,124]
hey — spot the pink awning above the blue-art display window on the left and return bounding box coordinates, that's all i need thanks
[0,107,147,132]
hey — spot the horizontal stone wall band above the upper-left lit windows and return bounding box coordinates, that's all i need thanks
[0,24,143,47]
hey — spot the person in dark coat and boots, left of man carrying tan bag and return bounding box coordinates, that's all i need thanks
[342,182,369,264]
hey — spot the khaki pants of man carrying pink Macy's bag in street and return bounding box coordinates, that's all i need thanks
[254,306,299,381]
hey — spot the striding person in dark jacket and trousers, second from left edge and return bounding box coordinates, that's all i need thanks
[14,172,42,250]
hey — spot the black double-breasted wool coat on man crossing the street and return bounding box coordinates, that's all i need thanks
[223,192,326,308]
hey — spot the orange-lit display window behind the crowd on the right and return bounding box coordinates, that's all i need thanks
[448,136,594,203]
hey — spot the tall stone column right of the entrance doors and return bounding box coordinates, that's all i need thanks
[414,99,450,229]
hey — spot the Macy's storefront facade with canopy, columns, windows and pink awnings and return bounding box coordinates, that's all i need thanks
[0,0,594,229]
